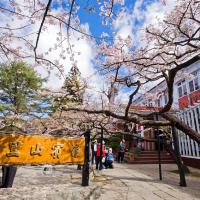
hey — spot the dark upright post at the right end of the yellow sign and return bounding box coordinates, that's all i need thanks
[82,129,90,186]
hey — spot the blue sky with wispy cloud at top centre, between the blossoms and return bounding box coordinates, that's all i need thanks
[49,0,174,101]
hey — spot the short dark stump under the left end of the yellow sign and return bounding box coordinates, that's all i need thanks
[1,165,17,188]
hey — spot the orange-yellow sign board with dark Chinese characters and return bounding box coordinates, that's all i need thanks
[0,134,85,165]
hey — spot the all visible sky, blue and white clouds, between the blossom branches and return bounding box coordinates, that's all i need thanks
[0,0,175,104]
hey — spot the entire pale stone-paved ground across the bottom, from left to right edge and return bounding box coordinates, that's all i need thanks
[0,163,200,200]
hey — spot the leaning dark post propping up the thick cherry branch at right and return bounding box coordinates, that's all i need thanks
[172,126,187,187]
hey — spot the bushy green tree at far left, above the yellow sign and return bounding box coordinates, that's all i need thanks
[0,62,42,114]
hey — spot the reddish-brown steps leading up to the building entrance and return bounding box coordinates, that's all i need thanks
[125,151,175,164]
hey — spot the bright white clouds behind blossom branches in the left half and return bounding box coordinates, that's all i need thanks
[0,0,103,94]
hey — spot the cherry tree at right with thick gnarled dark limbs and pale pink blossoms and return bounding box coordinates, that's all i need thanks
[63,1,200,142]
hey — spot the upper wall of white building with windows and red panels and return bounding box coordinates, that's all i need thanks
[133,62,200,110]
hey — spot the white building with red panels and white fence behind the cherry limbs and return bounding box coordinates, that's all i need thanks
[132,62,200,168]
